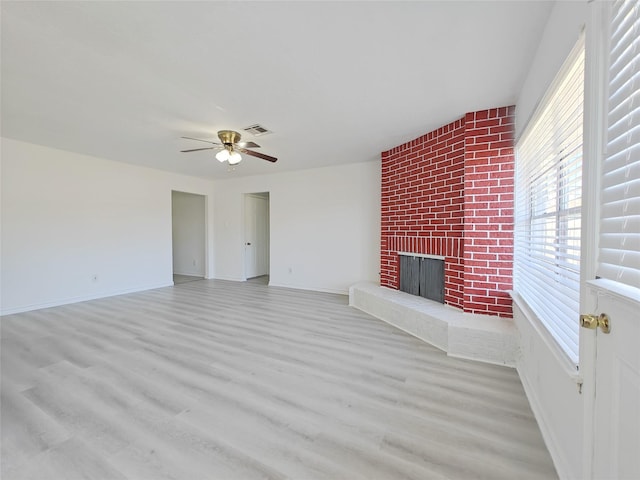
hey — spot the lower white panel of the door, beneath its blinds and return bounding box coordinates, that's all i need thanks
[585,281,640,480]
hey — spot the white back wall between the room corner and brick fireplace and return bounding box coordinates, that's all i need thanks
[214,162,380,293]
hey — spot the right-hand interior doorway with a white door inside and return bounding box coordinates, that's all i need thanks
[244,192,270,279]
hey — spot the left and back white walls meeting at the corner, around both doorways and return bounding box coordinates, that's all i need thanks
[0,139,380,314]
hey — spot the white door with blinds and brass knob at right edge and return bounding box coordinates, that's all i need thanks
[580,1,640,480]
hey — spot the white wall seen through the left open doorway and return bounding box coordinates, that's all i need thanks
[171,192,206,277]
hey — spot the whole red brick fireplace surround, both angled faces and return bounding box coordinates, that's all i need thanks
[380,106,515,317]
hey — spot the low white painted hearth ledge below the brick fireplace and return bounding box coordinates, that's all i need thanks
[349,282,518,367]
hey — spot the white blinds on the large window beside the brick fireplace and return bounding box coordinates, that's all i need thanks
[514,38,584,364]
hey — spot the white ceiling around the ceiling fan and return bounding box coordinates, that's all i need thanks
[0,1,551,178]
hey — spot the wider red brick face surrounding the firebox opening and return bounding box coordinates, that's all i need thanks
[381,119,465,308]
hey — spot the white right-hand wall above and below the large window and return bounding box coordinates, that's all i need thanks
[514,1,588,478]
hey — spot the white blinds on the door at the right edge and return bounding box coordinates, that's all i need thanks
[598,1,640,288]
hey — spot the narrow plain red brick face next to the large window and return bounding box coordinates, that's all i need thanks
[464,107,515,316]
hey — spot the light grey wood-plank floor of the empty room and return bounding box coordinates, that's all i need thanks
[0,279,556,480]
